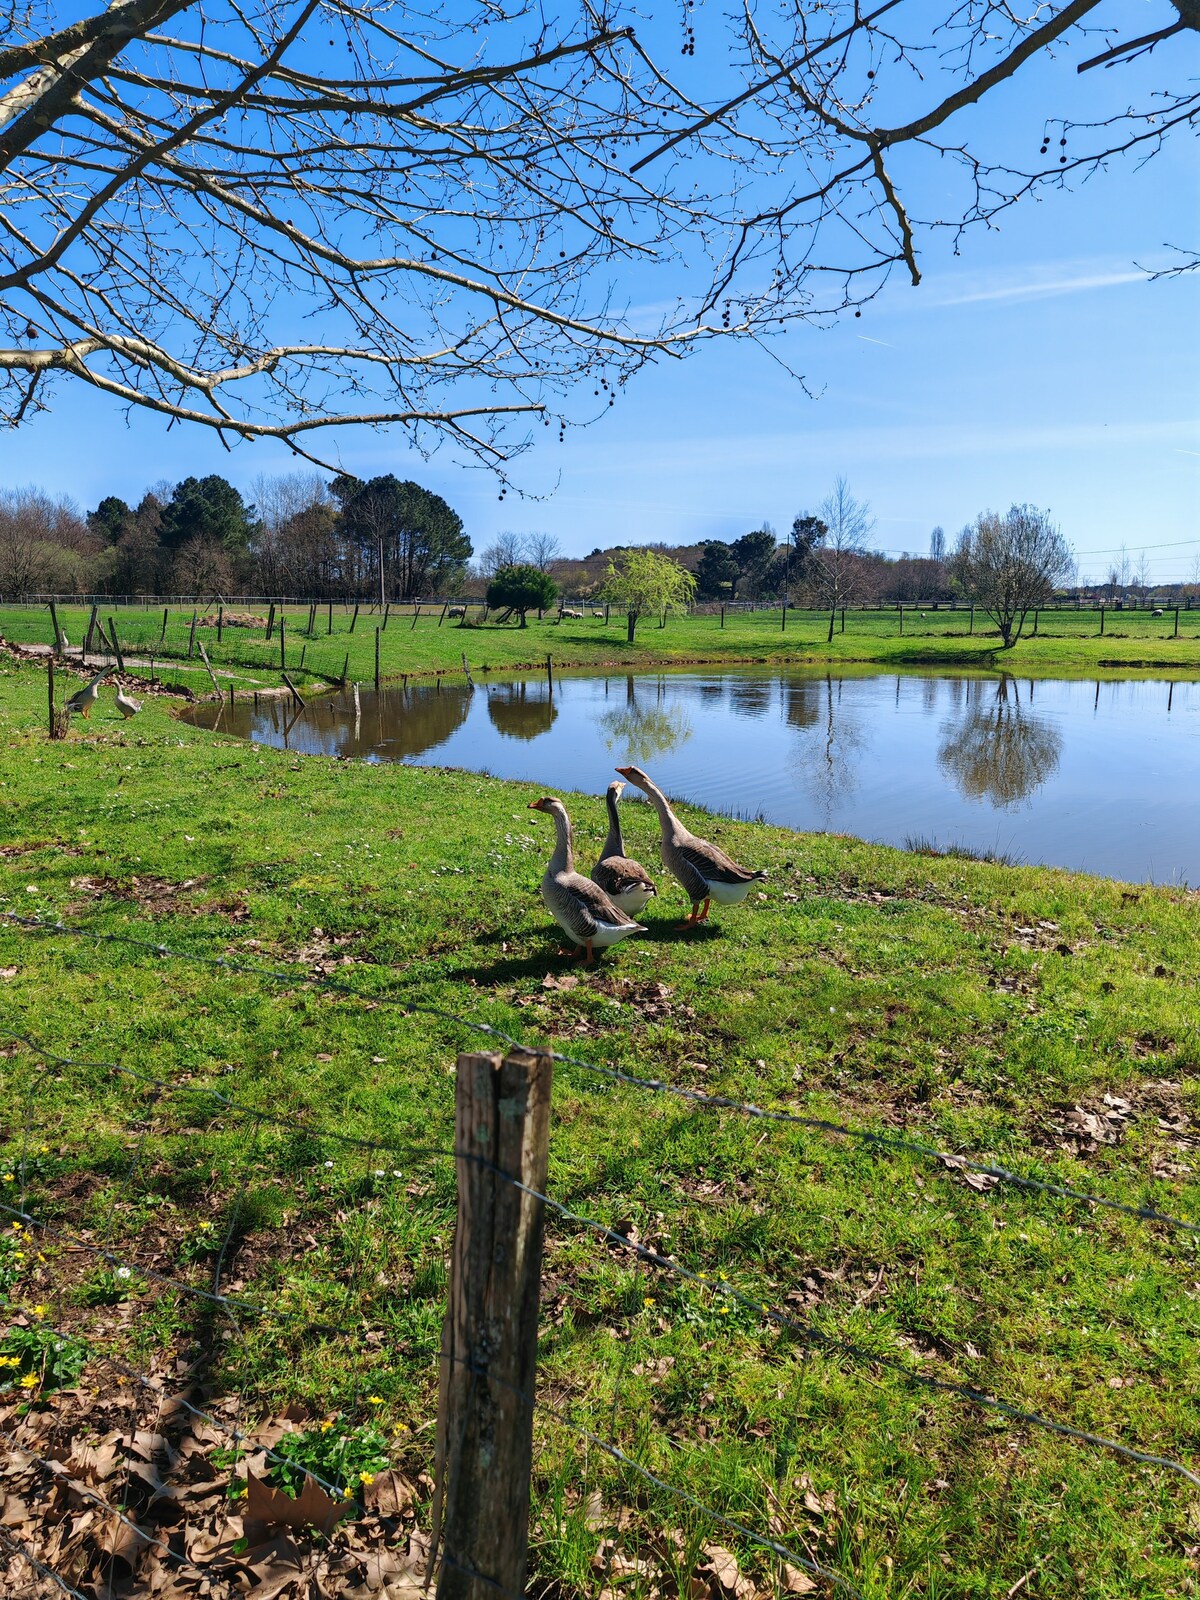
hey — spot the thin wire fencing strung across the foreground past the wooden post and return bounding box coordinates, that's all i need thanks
[0,912,1200,1600]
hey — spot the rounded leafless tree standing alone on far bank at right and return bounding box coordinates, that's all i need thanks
[954,506,1075,650]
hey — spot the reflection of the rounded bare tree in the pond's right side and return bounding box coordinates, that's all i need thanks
[938,678,1062,806]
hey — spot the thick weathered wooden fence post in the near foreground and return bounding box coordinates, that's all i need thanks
[430,1048,552,1600]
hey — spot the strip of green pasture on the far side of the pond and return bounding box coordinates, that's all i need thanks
[0,606,1200,693]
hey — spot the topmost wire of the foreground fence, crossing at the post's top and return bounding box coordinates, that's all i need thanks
[0,910,1200,1235]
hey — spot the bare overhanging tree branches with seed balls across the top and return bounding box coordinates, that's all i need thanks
[0,0,1200,470]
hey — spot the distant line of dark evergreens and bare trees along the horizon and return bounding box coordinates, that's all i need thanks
[0,472,1200,618]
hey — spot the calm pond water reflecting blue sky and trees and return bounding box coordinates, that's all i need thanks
[189,669,1200,885]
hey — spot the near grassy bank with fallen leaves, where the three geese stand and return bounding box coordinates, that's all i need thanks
[0,652,1200,1600]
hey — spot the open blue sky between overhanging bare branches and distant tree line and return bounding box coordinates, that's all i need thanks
[0,6,1200,581]
